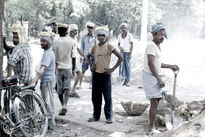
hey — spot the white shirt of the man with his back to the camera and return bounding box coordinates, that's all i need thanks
[53,37,76,69]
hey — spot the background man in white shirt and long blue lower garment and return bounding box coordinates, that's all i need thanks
[118,23,133,86]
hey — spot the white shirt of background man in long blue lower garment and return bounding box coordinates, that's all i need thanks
[118,32,133,52]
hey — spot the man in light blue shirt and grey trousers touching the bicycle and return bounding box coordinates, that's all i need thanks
[31,32,56,130]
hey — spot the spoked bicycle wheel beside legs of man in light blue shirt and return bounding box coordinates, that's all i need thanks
[14,90,48,137]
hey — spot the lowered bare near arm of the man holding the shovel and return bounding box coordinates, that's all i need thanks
[147,54,165,88]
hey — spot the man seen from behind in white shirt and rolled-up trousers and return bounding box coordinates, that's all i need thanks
[53,23,76,115]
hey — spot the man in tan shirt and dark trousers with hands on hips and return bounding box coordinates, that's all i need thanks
[88,26,122,124]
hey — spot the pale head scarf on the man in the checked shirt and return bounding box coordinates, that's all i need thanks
[11,25,28,43]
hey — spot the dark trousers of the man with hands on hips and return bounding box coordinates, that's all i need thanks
[92,72,112,119]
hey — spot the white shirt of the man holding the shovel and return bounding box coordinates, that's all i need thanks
[144,41,162,75]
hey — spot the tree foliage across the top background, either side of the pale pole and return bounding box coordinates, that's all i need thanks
[5,0,204,37]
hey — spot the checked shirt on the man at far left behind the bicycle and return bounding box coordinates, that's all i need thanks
[8,44,33,84]
